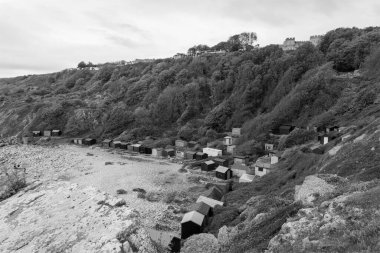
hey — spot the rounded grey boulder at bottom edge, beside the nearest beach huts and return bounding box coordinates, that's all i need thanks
[181,234,219,253]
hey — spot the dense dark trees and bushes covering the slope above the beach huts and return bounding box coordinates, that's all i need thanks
[0,27,380,153]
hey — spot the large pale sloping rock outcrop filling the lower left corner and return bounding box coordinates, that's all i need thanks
[0,182,156,253]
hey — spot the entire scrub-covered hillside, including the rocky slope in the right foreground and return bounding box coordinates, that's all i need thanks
[0,27,380,252]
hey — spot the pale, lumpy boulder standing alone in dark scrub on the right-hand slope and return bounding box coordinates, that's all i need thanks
[294,176,335,205]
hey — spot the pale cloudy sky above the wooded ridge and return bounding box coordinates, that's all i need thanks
[0,0,380,77]
